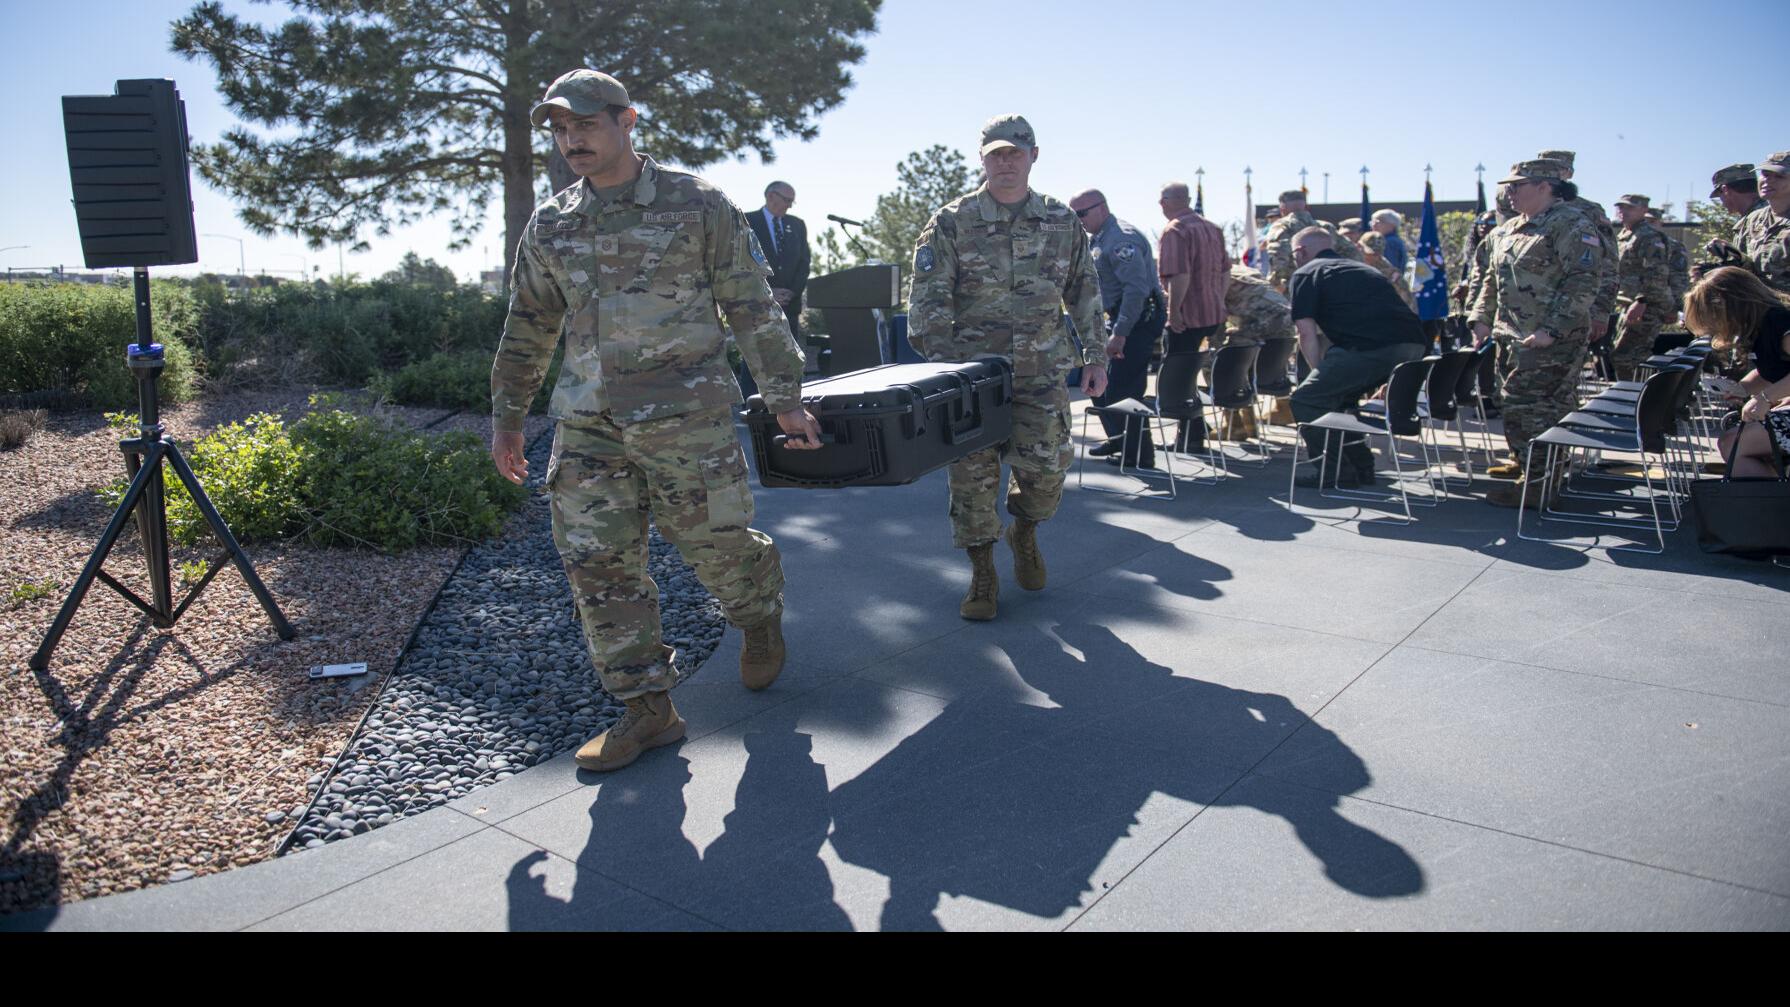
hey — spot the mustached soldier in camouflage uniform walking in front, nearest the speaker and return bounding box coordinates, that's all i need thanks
[490,70,820,771]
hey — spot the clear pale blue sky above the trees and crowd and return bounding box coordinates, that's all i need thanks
[0,0,1790,279]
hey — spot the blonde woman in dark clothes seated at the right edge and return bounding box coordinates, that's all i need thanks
[1684,267,1790,478]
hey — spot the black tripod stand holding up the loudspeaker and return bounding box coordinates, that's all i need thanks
[30,267,297,671]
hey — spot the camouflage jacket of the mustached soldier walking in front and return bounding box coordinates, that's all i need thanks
[490,157,802,431]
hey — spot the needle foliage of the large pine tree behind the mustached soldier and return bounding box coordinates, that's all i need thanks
[172,0,881,273]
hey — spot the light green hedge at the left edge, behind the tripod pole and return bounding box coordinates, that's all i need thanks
[0,281,199,408]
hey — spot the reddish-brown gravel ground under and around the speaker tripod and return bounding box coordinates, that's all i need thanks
[0,390,548,912]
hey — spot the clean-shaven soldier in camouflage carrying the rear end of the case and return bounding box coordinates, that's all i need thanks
[908,114,1106,621]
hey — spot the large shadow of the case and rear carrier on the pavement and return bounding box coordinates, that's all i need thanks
[832,622,1423,930]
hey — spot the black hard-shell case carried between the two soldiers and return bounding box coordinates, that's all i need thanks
[746,358,1013,490]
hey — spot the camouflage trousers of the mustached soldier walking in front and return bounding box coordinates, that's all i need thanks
[548,406,784,699]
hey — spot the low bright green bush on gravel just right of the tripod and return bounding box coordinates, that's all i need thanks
[100,404,528,553]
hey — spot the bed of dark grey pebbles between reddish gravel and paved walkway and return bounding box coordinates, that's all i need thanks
[286,432,725,851]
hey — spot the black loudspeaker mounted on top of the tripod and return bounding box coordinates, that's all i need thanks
[63,80,199,268]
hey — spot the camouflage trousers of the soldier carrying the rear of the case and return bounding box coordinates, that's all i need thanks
[945,374,1076,549]
